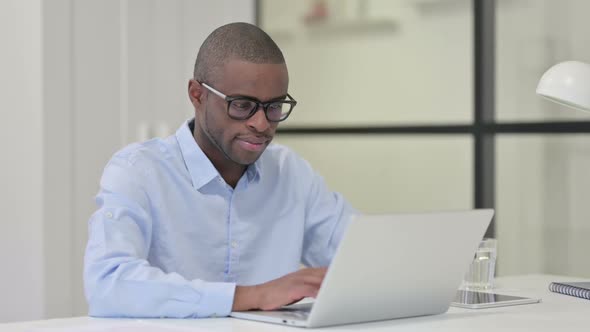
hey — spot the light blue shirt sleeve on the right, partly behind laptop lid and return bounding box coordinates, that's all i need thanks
[302,162,359,267]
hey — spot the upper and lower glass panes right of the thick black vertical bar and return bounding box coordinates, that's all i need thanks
[495,0,590,277]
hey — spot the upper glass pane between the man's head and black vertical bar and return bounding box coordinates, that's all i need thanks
[260,0,473,126]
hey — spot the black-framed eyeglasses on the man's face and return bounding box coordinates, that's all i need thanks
[201,83,297,122]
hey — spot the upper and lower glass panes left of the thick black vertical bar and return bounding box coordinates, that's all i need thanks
[258,0,473,213]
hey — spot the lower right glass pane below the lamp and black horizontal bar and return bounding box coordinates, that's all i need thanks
[496,135,590,277]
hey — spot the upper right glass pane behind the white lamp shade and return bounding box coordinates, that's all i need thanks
[496,0,590,121]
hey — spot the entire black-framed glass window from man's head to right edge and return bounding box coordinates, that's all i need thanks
[258,0,590,277]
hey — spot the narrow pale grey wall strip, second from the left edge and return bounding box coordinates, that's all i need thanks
[41,0,76,317]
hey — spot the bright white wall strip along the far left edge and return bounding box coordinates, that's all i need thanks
[0,0,45,321]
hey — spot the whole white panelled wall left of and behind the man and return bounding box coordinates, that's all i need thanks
[0,0,254,322]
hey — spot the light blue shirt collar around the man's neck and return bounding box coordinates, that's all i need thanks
[176,119,261,189]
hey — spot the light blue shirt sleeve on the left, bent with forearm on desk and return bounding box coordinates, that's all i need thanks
[84,156,236,318]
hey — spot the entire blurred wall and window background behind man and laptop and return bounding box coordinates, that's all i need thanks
[0,0,590,322]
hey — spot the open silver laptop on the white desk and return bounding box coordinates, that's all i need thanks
[230,209,494,327]
